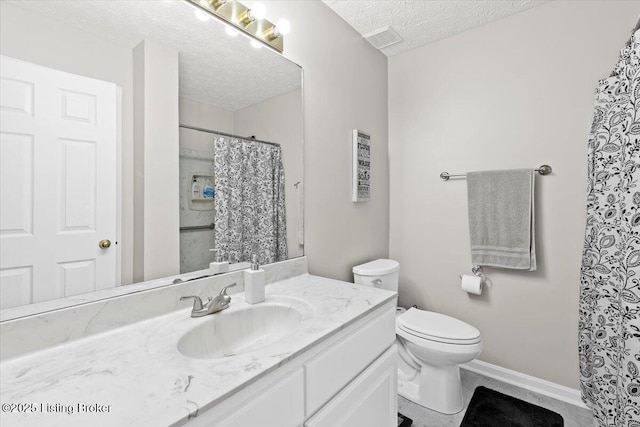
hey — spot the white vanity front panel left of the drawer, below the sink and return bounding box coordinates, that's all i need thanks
[216,369,304,427]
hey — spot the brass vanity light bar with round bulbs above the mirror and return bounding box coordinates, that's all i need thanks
[185,0,289,53]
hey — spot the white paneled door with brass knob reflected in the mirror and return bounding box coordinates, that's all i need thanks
[0,56,117,308]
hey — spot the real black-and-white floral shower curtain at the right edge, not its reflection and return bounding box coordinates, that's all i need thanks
[579,31,640,427]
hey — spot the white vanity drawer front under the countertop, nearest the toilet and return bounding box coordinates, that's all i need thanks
[304,305,396,417]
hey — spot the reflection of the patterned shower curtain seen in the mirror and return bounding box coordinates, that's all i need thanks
[214,136,287,264]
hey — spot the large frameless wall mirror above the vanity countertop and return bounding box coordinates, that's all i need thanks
[0,0,304,320]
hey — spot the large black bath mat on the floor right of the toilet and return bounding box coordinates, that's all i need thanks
[460,386,564,427]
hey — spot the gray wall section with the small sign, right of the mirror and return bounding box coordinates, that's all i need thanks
[268,1,389,281]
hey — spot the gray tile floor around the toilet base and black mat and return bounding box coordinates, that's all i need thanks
[398,369,597,427]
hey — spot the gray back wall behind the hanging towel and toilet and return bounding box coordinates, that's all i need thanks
[389,1,640,388]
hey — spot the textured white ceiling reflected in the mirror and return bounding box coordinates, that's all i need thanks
[7,0,302,111]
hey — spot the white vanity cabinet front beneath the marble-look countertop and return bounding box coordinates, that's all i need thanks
[187,301,397,427]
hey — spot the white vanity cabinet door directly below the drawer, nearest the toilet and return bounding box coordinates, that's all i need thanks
[304,345,398,427]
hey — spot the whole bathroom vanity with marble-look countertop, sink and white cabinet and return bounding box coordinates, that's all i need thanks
[0,273,397,427]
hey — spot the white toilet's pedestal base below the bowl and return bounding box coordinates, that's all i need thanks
[398,364,463,415]
